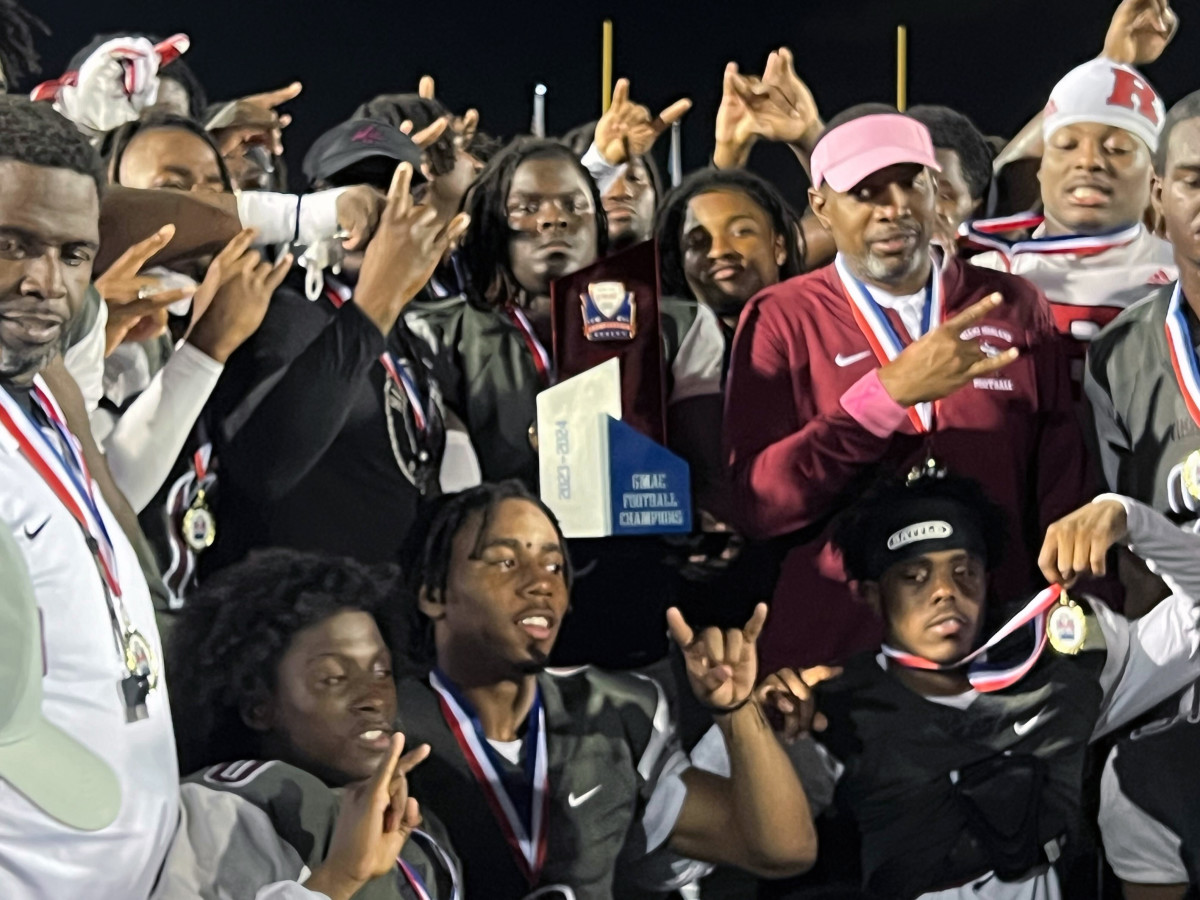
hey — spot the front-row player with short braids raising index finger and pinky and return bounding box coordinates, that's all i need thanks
[400,481,816,900]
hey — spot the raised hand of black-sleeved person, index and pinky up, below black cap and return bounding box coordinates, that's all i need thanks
[354,162,470,334]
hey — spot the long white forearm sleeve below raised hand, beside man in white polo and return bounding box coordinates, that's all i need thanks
[103,343,223,512]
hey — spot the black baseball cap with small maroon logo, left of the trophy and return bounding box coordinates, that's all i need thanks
[304,119,425,190]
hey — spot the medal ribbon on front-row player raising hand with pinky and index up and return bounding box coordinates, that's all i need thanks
[430,671,550,884]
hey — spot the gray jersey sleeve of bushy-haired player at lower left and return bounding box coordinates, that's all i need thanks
[151,784,328,900]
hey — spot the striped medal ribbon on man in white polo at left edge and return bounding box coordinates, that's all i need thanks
[0,376,121,598]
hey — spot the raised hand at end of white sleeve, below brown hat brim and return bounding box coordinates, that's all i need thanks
[187,228,292,362]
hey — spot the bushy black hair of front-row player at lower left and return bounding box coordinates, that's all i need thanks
[167,548,407,773]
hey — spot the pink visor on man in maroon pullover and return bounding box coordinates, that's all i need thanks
[812,113,942,193]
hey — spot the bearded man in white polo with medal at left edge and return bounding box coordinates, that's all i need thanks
[0,97,179,900]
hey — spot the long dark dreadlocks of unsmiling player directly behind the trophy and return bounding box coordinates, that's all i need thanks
[460,137,608,306]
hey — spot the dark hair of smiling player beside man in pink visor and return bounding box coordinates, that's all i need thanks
[654,169,804,298]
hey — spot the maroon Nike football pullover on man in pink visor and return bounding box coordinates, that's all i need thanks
[725,259,1086,672]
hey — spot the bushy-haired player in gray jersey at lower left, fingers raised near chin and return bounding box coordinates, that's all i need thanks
[155,550,457,900]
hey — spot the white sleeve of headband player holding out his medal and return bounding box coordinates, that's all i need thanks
[1091,494,1200,739]
